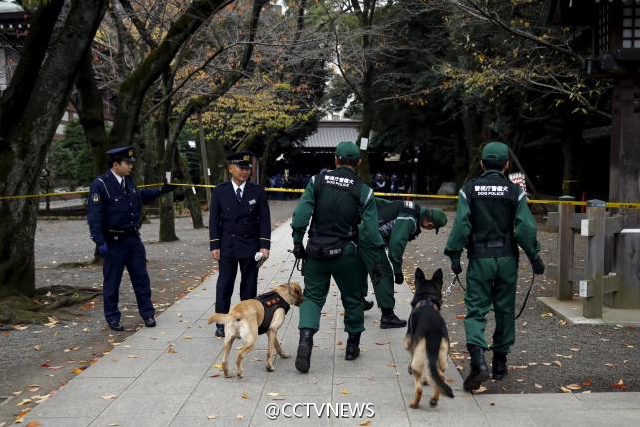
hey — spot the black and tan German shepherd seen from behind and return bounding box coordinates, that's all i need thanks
[404,268,453,409]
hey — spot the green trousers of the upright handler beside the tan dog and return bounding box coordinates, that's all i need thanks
[298,244,367,333]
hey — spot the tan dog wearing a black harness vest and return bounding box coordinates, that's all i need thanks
[209,282,302,378]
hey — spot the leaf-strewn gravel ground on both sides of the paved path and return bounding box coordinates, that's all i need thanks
[0,201,640,426]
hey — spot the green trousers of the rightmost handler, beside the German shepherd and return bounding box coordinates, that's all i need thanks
[464,257,518,353]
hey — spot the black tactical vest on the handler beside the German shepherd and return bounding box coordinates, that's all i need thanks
[463,171,521,258]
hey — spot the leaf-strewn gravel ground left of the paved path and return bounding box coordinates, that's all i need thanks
[0,200,295,426]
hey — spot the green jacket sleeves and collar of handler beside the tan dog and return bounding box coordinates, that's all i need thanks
[291,166,384,247]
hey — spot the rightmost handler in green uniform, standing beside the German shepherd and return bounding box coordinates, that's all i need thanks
[444,142,544,391]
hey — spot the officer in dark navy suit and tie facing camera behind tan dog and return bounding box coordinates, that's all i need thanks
[209,151,271,337]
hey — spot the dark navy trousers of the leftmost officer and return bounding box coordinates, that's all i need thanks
[102,234,155,322]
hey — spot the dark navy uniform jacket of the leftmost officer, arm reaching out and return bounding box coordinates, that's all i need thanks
[87,170,162,246]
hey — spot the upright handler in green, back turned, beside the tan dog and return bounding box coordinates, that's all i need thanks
[291,142,384,373]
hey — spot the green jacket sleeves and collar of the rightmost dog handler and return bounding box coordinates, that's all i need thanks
[444,170,540,262]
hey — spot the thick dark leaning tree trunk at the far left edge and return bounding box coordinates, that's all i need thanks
[0,0,106,295]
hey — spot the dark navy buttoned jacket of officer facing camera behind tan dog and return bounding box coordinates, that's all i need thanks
[209,181,271,259]
